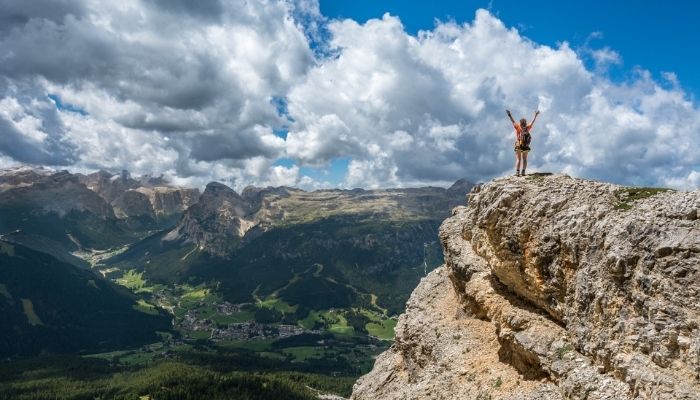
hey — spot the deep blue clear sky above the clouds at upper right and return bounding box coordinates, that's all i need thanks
[320,0,700,101]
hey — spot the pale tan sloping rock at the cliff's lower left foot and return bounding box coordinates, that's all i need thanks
[351,266,562,400]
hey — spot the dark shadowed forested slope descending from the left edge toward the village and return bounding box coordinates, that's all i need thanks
[0,241,170,356]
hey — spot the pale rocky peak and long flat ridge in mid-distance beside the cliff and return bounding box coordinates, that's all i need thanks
[165,182,471,256]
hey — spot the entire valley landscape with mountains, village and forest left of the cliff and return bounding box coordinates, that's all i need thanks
[0,167,471,399]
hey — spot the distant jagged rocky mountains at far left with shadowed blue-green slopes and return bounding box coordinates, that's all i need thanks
[0,166,199,255]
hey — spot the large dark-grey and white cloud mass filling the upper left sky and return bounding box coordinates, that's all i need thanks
[0,0,314,188]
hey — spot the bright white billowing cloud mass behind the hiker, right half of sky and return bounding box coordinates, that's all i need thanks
[287,10,700,187]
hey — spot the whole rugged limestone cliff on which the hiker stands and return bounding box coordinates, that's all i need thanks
[352,175,700,400]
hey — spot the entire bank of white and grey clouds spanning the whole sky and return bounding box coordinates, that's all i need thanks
[0,0,700,189]
